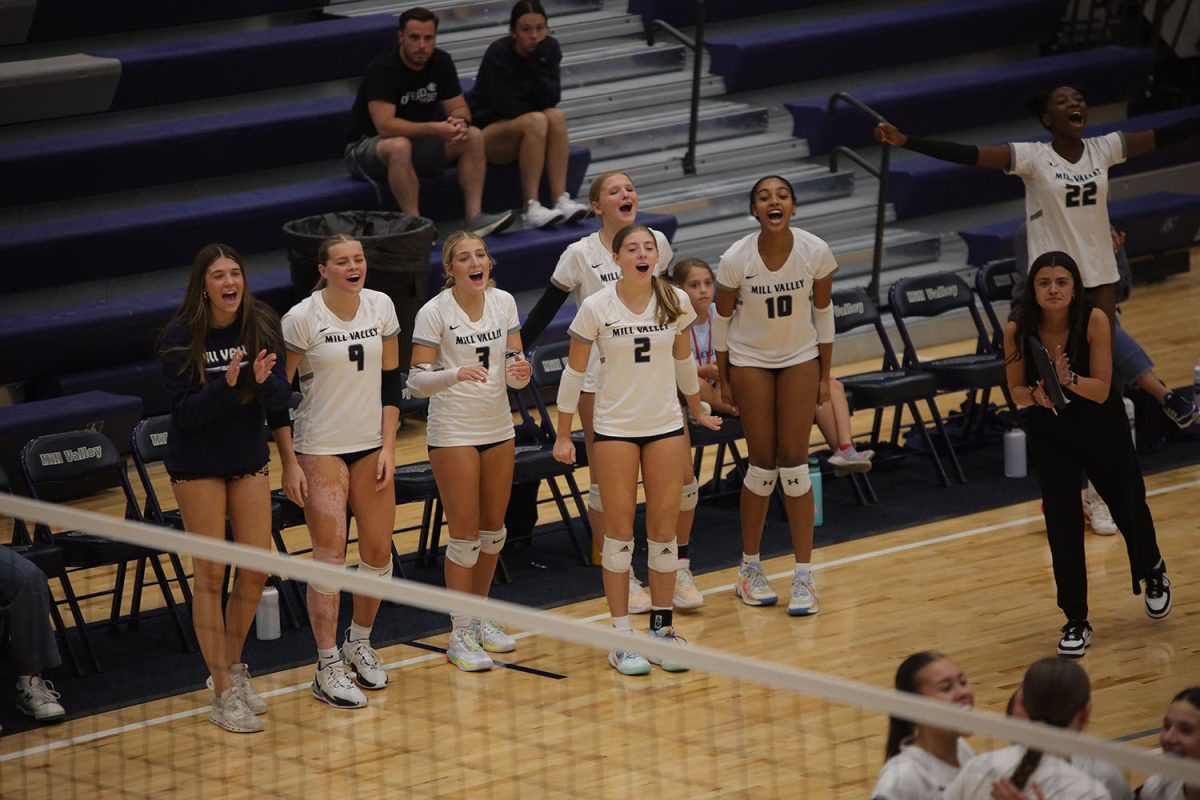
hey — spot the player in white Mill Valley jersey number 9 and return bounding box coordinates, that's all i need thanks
[276,235,403,708]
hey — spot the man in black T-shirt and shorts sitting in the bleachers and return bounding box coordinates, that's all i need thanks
[346,7,512,236]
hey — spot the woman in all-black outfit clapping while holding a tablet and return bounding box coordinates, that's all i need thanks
[1004,252,1171,657]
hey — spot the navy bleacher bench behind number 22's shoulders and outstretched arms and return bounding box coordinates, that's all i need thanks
[888,106,1200,219]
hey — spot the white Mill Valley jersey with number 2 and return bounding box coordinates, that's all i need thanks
[570,284,696,437]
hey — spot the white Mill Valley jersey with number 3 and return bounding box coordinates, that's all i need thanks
[413,288,521,447]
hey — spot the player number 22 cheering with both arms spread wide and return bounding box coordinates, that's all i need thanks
[875,86,1200,326]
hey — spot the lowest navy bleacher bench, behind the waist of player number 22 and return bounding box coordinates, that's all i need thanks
[959,192,1200,266]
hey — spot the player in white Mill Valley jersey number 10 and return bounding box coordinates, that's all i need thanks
[713,175,838,616]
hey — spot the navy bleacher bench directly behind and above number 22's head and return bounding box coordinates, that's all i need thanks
[785,47,1157,154]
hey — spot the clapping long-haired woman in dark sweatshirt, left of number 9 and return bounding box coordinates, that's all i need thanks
[160,245,292,733]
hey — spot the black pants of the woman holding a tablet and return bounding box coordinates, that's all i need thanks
[1030,398,1160,620]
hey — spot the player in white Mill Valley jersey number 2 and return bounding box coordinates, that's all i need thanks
[554,224,721,675]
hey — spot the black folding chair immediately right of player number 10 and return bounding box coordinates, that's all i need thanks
[833,289,966,495]
